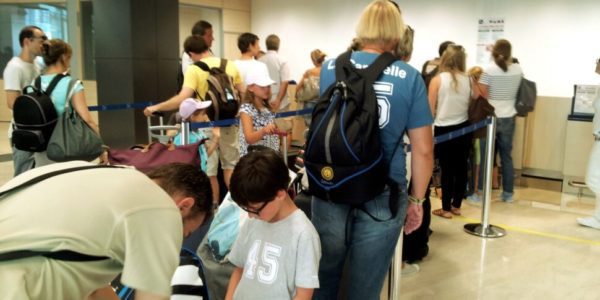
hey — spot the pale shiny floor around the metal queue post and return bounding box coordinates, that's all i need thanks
[401,189,600,299]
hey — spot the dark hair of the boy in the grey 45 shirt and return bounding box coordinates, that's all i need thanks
[230,146,290,206]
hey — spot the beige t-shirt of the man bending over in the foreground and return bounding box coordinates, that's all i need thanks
[0,161,183,299]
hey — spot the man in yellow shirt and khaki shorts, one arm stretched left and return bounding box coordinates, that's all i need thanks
[144,36,243,203]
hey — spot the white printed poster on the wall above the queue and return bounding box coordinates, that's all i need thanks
[477,17,504,66]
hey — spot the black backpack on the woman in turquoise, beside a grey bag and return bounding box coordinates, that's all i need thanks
[12,74,65,152]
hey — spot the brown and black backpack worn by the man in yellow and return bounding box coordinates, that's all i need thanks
[194,58,240,121]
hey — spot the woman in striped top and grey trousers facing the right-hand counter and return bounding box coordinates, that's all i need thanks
[473,39,523,203]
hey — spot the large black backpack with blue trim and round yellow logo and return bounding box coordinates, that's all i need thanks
[304,51,396,205]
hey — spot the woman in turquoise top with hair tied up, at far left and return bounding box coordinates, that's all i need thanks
[32,39,100,167]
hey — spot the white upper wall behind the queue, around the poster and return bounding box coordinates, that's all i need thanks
[251,0,600,97]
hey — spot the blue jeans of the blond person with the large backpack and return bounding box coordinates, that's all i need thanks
[312,188,408,300]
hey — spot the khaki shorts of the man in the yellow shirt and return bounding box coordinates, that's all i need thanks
[206,126,240,176]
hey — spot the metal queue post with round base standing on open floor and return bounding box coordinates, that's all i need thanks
[464,117,506,238]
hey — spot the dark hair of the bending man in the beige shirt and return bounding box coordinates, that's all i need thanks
[147,163,212,218]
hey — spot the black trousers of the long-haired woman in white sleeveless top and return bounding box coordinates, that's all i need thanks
[434,122,473,211]
